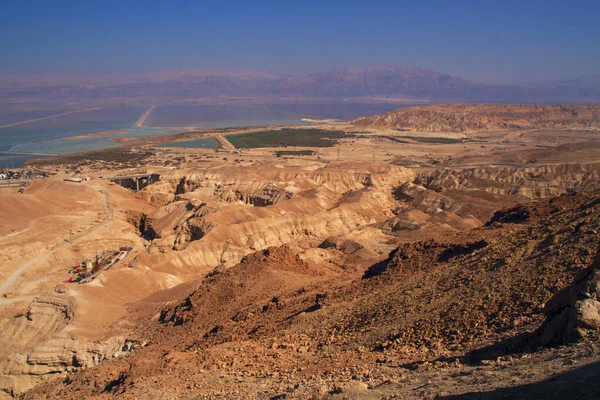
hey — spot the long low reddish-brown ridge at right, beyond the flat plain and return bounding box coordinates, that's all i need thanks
[352,104,600,132]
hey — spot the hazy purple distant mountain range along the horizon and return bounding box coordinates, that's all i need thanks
[0,66,600,103]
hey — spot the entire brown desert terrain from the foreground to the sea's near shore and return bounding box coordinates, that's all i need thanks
[0,104,600,399]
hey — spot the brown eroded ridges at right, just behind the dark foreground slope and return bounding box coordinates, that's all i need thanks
[384,164,600,234]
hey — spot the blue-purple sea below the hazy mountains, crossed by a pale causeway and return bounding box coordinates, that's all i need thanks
[0,101,406,169]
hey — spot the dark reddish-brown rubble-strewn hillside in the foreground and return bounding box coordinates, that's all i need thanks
[24,191,600,399]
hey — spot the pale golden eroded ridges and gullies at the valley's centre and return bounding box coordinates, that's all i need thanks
[129,165,414,275]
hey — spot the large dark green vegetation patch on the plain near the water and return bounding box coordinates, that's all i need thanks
[227,129,353,149]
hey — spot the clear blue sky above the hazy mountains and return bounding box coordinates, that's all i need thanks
[0,0,600,83]
